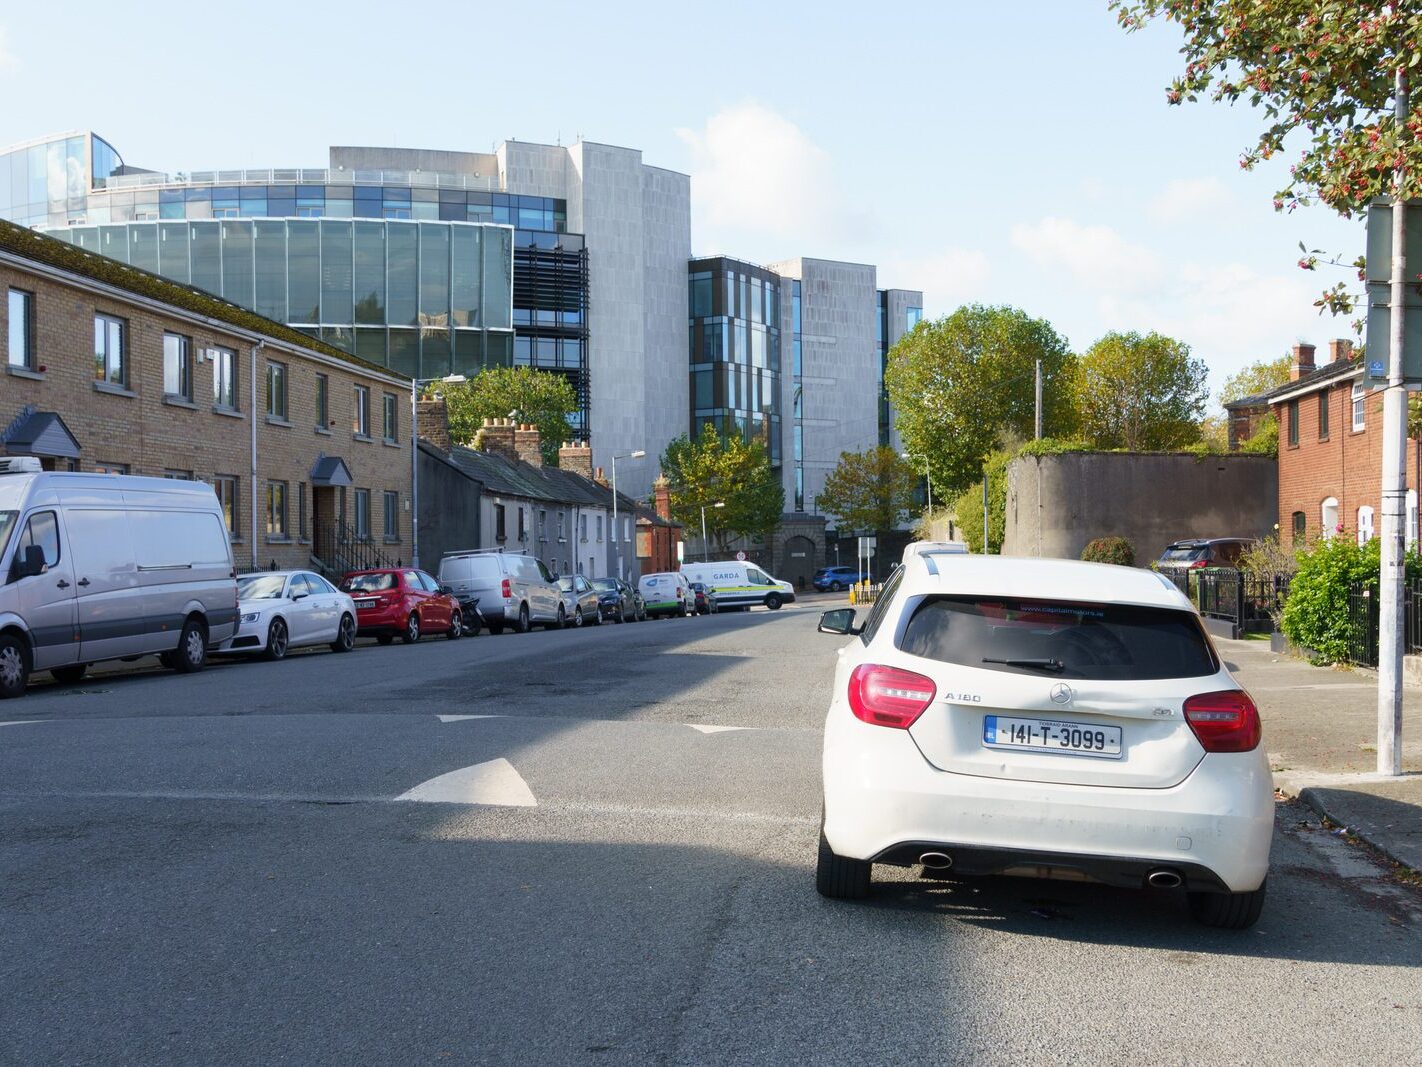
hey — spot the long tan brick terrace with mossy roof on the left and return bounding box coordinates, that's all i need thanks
[0,222,412,573]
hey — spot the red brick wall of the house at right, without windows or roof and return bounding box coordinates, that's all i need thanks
[1274,378,1418,543]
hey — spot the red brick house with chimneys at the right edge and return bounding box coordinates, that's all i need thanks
[1266,341,1419,545]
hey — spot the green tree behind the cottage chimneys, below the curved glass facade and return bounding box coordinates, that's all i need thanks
[425,367,577,465]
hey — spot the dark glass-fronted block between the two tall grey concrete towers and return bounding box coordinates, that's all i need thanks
[688,256,782,467]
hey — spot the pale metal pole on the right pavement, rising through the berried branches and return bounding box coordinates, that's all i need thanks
[1378,58,1408,775]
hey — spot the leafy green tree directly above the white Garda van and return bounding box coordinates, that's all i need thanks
[661,423,785,551]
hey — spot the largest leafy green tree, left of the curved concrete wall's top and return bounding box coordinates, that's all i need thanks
[884,304,1075,497]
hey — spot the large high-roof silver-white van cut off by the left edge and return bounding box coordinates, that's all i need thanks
[0,457,237,697]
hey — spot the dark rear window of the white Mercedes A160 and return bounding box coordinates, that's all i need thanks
[899,596,1219,681]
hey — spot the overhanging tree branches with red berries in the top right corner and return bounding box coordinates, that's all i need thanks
[1111,0,1422,313]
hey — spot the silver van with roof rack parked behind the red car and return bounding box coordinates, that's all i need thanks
[439,548,567,633]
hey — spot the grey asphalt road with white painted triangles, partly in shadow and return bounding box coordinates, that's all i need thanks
[0,605,1422,1064]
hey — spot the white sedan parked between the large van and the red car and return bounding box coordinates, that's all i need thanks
[218,570,356,660]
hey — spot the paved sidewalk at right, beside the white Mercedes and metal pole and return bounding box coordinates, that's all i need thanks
[1214,637,1422,871]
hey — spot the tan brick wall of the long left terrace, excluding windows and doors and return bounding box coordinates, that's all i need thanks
[0,263,411,577]
